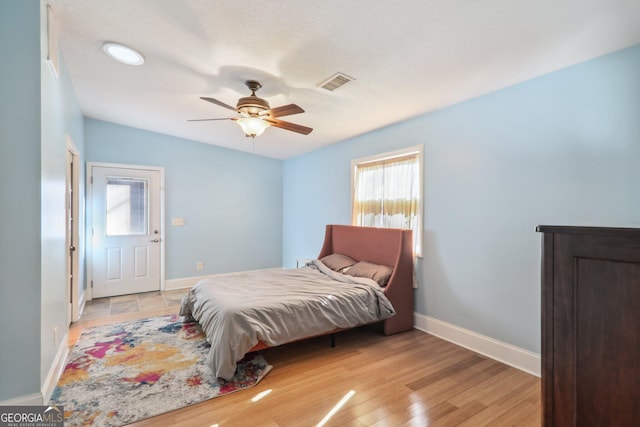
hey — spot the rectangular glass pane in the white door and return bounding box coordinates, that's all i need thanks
[106,177,149,236]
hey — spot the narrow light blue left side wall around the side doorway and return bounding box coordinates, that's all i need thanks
[40,2,84,394]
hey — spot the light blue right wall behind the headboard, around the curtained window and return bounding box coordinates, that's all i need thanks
[283,47,640,352]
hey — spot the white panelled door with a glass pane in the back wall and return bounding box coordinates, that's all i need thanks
[91,166,161,298]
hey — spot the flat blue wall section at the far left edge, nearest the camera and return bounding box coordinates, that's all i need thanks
[0,0,40,400]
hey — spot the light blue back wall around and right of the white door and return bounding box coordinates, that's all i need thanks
[85,119,282,279]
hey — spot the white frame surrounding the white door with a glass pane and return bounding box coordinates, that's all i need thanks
[85,162,165,301]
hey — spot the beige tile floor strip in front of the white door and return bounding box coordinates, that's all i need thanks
[81,289,188,320]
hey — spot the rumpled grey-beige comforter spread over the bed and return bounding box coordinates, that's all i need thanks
[180,260,395,380]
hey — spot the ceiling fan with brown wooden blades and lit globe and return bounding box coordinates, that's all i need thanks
[189,80,313,138]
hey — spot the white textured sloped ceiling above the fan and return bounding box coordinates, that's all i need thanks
[50,0,640,159]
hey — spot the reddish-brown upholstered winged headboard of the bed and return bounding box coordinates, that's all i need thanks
[318,224,413,335]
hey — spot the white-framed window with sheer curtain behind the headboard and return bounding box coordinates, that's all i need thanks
[351,145,423,256]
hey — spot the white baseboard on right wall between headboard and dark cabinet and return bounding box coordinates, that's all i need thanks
[414,313,541,377]
